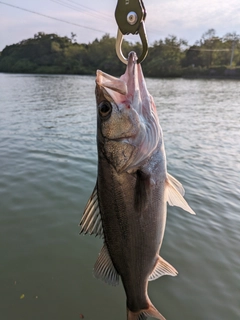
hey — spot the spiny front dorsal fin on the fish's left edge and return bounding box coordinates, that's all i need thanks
[79,183,103,237]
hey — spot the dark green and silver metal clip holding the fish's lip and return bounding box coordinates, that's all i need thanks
[115,0,148,64]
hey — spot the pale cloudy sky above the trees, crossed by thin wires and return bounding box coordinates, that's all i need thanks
[0,0,240,51]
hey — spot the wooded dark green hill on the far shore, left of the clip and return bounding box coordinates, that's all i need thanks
[0,32,127,74]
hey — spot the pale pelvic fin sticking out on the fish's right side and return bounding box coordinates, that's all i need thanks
[166,174,196,214]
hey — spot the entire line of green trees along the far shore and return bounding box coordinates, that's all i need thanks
[0,29,240,78]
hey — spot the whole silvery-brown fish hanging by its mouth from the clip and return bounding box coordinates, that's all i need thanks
[80,52,195,320]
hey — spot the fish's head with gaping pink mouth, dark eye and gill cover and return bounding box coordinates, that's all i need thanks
[96,52,162,172]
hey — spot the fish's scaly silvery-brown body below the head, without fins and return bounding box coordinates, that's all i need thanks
[98,152,166,311]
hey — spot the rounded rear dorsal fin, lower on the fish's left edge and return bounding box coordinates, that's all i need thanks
[94,244,119,286]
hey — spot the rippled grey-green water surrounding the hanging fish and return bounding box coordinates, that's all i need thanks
[0,74,240,320]
